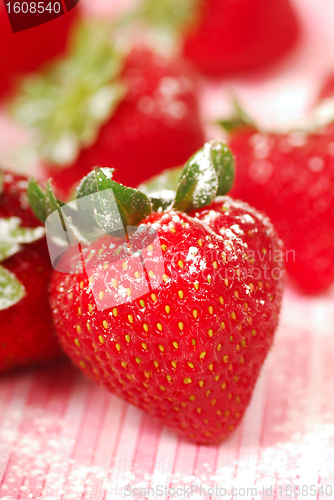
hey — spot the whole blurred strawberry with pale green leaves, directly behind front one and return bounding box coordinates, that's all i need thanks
[13,25,204,196]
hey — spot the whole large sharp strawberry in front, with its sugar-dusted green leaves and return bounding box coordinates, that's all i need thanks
[30,142,284,443]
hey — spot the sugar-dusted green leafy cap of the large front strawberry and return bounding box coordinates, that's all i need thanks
[28,141,234,249]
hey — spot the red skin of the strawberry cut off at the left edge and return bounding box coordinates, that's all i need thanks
[0,173,61,372]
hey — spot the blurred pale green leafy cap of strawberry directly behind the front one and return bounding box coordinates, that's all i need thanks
[12,22,126,167]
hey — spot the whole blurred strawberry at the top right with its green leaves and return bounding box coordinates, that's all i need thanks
[141,0,300,77]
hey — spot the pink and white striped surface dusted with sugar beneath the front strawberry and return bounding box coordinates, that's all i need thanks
[0,290,334,500]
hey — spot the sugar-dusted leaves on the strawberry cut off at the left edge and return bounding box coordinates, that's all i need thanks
[0,171,45,311]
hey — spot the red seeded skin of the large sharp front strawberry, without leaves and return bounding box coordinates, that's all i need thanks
[50,197,284,443]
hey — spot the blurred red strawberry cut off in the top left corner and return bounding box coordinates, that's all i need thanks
[0,2,78,96]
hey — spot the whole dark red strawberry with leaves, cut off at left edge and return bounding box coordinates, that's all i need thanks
[0,172,60,372]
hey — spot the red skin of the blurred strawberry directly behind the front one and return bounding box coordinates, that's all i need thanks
[46,48,204,198]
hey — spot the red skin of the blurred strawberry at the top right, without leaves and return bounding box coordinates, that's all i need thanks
[184,0,299,76]
